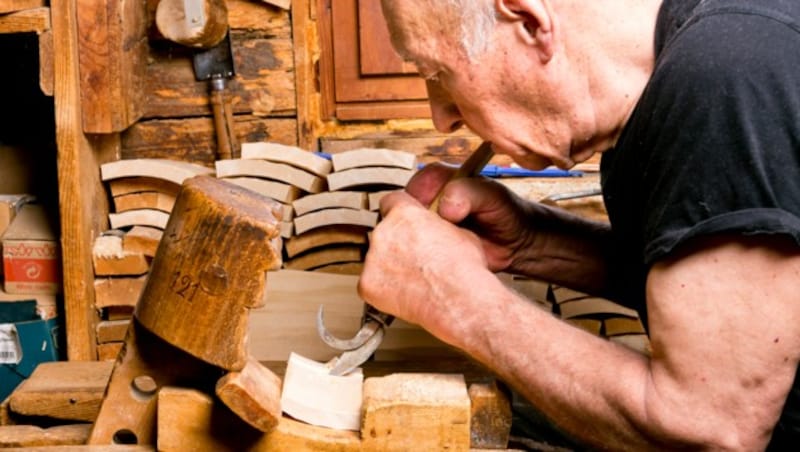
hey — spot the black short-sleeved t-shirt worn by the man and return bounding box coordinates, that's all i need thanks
[601,0,800,444]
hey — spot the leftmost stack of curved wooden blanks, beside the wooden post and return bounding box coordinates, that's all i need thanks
[92,159,214,359]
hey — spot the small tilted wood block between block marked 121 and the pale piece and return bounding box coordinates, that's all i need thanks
[215,357,281,433]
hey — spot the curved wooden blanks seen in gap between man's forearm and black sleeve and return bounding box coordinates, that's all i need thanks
[551,286,650,355]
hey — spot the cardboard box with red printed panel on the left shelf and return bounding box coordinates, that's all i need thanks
[3,204,61,294]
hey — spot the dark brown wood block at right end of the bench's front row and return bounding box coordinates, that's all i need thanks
[468,381,511,449]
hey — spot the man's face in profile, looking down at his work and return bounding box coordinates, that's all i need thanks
[385,1,596,169]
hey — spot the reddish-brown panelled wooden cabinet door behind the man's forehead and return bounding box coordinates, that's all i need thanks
[319,0,430,120]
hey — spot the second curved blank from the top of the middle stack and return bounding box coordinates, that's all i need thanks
[216,159,326,193]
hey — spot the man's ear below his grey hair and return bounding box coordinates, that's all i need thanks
[495,0,554,63]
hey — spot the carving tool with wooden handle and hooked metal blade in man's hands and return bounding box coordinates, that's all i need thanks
[317,141,494,375]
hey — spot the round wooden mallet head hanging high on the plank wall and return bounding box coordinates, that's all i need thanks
[156,0,228,49]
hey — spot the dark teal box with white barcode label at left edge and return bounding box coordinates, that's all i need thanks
[0,300,60,400]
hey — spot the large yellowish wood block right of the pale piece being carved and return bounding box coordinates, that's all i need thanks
[361,373,470,451]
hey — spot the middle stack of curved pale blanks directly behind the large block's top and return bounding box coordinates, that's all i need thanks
[216,142,331,245]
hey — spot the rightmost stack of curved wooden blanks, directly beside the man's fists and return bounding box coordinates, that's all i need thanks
[284,149,417,274]
